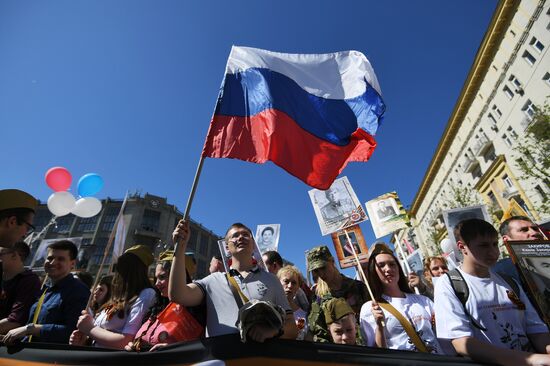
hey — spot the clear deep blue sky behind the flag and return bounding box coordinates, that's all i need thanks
[0,0,497,274]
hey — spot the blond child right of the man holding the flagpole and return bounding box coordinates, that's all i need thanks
[277,265,309,340]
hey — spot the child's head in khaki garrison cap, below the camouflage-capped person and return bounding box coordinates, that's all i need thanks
[323,298,358,345]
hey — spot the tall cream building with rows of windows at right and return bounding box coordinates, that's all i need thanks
[398,0,550,255]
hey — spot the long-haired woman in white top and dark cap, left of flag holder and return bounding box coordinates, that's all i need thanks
[69,245,156,349]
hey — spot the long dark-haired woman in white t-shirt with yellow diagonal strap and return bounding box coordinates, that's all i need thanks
[360,244,443,354]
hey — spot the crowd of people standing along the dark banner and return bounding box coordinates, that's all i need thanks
[0,190,550,365]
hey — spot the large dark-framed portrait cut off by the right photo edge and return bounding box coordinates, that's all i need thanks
[504,240,550,327]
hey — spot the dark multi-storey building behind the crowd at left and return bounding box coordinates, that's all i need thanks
[29,193,220,278]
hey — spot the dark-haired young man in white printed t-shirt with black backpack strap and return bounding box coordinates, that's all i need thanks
[435,219,550,366]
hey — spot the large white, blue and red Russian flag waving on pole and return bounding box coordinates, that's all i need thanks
[202,47,386,190]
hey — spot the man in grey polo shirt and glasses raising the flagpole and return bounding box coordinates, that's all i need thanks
[168,220,298,342]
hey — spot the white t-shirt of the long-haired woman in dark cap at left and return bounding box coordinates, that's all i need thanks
[94,288,157,346]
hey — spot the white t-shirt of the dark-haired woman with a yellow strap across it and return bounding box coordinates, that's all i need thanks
[360,293,444,354]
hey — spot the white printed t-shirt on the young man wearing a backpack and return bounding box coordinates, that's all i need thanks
[434,268,548,351]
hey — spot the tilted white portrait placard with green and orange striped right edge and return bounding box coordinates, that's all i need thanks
[365,192,409,239]
